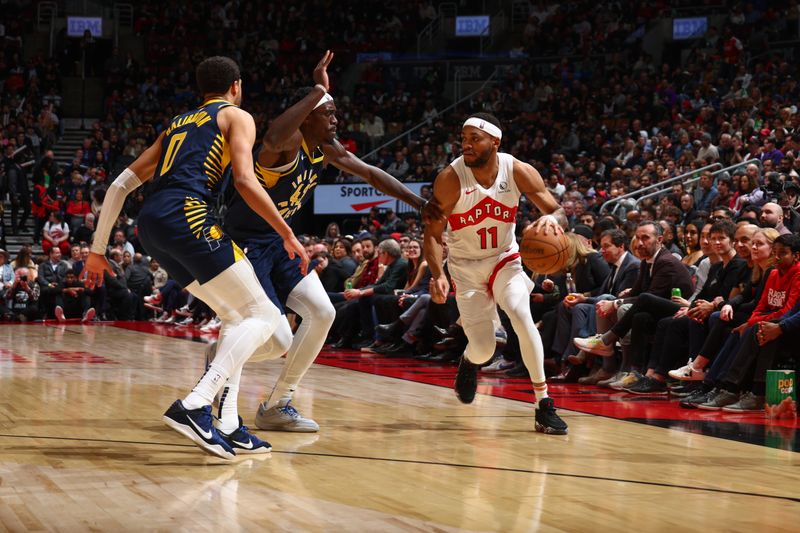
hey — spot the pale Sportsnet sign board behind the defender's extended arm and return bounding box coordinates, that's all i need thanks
[314,183,430,215]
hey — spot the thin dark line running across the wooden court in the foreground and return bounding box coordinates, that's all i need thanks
[0,433,800,503]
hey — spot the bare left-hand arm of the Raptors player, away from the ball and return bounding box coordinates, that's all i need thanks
[422,167,461,304]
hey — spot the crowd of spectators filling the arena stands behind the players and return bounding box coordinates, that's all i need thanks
[0,0,800,412]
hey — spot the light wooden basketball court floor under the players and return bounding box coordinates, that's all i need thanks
[0,324,800,532]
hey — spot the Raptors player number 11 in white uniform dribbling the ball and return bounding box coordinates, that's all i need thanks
[424,113,567,435]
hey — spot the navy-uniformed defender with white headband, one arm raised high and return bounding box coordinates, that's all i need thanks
[216,52,436,432]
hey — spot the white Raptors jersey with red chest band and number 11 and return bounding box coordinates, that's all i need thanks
[447,153,520,259]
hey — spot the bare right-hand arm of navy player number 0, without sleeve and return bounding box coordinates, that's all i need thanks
[228,106,309,275]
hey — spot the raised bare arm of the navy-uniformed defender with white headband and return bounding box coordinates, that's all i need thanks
[261,50,333,156]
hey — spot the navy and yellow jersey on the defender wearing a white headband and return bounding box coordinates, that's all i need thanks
[225,140,324,243]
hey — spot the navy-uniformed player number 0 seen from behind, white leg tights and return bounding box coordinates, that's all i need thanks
[85,57,308,459]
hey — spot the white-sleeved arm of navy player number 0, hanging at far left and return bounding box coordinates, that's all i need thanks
[81,133,164,289]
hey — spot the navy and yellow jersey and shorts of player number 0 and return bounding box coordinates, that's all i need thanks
[139,99,244,286]
